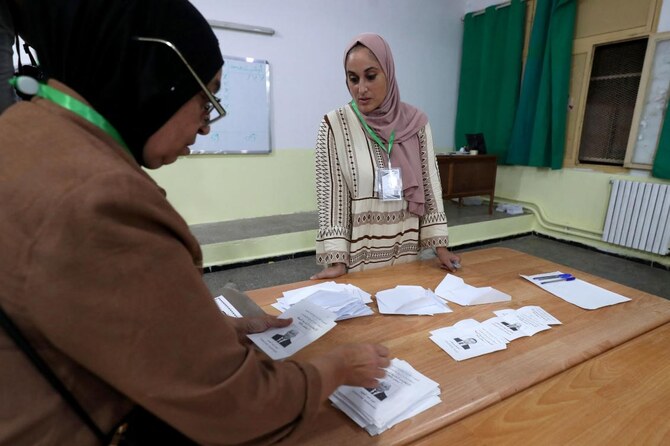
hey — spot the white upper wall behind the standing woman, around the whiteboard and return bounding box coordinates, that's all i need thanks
[192,0,465,150]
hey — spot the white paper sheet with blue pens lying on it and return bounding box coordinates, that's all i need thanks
[521,271,630,310]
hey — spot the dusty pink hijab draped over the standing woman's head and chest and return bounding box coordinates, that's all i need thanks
[344,33,428,216]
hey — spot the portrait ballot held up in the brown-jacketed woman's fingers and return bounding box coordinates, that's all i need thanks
[247,300,336,359]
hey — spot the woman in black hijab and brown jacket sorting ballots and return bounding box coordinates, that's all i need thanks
[0,0,389,445]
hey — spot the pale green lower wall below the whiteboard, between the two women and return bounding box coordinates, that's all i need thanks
[149,149,316,225]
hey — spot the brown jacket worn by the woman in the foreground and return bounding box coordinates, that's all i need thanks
[0,86,321,445]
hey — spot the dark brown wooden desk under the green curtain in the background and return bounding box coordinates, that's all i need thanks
[437,155,498,214]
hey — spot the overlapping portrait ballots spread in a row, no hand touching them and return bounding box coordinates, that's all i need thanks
[430,306,561,361]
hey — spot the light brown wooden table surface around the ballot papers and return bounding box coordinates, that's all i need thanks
[249,248,670,445]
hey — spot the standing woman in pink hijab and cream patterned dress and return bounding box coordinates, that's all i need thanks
[312,33,460,279]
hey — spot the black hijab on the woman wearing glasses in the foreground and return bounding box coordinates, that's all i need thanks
[13,0,223,164]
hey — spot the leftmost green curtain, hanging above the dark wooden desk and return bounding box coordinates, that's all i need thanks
[454,0,526,162]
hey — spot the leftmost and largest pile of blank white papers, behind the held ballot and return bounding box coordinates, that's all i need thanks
[272,282,374,321]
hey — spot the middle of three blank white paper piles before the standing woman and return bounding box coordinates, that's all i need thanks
[375,285,451,316]
